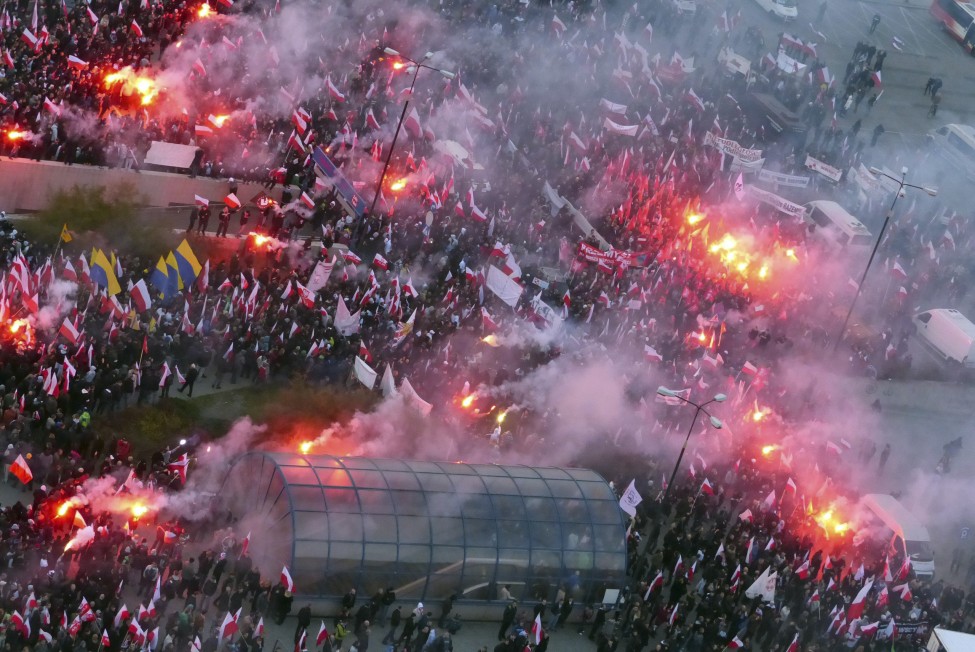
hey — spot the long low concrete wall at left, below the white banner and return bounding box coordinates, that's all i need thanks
[0,158,280,213]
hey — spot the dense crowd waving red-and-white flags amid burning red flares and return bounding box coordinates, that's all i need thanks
[0,2,973,652]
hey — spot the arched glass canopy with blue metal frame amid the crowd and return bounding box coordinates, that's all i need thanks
[220,452,626,600]
